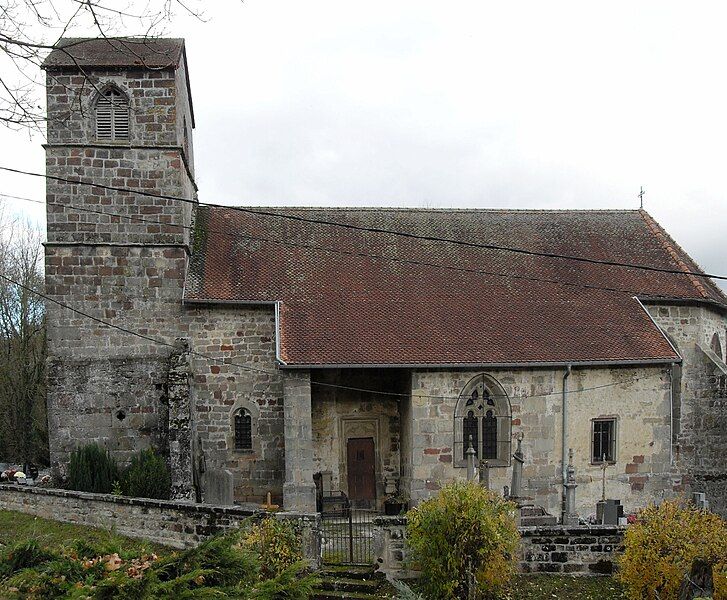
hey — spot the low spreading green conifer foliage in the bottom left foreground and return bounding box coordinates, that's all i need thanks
[0,529,318,600]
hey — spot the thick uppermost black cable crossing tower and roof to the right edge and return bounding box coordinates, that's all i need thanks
[0,166,727,281]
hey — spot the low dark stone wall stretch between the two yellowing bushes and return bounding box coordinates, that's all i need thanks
[520,525,626,575]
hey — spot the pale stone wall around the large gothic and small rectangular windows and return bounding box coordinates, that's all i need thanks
[404,366,672,516]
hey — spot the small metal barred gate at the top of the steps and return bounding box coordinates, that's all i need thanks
[321,508,378,565]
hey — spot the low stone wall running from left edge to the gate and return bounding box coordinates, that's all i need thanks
[0,484,320,566]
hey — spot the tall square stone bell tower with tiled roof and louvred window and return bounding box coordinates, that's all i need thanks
[43,38,197,473]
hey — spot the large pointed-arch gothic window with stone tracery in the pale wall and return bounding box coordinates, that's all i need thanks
[454,374,512,467]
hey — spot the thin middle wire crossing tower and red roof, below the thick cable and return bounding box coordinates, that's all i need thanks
[0,193,724,299]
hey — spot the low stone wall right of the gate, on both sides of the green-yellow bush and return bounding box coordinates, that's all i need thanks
[374,517,626,579]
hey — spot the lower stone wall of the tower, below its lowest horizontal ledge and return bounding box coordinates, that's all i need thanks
[46,245,186,470]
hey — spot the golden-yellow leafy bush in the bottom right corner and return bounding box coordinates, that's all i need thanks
[618,500,727,600]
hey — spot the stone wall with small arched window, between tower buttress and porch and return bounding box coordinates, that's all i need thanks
[183,305,286,504]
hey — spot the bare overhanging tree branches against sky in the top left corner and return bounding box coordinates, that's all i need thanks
[0,0,202,132]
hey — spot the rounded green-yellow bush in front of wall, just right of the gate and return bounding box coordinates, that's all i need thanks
[406,482,520,600]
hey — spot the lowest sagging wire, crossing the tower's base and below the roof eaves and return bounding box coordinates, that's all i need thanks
[0,273,664,400]
